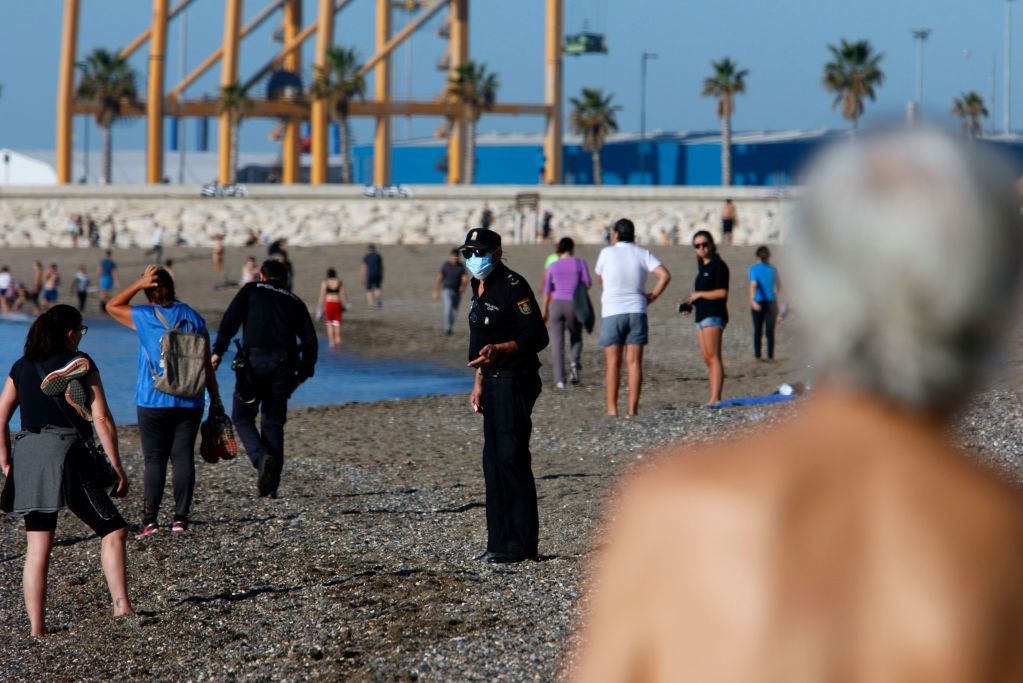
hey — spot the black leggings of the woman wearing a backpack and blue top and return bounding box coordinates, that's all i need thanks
[137,407,203,525]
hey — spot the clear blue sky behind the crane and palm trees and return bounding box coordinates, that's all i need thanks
[0,0,1010,151]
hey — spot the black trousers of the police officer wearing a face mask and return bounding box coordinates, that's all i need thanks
[482,372,541,557]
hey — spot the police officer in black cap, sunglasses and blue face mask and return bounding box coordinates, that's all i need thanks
[460,228,549,562]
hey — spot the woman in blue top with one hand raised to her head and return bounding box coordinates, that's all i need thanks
[106,266,223,538]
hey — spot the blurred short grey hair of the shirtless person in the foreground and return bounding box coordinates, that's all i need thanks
[790,130,1023,412]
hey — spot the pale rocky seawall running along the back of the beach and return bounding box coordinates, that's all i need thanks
[0,185,794,247]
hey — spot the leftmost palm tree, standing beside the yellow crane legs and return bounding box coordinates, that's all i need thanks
[78,47,138,185]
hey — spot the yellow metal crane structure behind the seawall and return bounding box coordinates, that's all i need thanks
[56,0,564,185]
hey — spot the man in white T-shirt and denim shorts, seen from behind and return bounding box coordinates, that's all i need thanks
[593,218,671,417]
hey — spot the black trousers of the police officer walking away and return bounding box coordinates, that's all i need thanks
[231,352,295,474]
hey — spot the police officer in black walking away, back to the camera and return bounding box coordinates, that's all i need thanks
[213,260,317,498]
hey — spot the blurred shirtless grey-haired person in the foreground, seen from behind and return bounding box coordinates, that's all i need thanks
[571,131,1023,683]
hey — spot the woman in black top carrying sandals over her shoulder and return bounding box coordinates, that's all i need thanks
[0,305,132,636]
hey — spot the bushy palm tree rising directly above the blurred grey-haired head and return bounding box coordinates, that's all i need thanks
[824,38,885,132]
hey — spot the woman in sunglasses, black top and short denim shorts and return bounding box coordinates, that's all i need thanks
[682,230,728,406]
